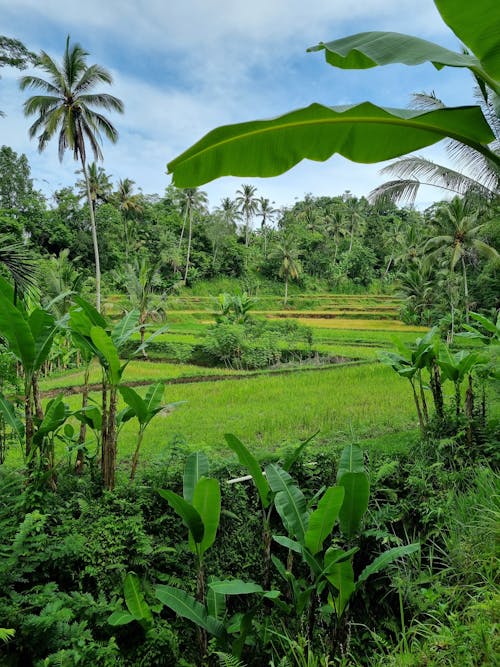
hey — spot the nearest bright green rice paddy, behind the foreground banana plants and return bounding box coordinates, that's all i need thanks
[45,364,416,472]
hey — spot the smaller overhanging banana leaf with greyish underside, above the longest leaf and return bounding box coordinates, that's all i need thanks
[307,31,479,69]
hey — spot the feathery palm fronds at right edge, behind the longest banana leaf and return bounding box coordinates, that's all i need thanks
[369,87,500,203]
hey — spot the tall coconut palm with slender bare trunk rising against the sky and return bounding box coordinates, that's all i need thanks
[20,36,123,310]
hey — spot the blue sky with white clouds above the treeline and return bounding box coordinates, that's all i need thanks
[0,0,472,206]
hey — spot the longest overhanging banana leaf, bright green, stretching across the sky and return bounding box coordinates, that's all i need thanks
[168,102,494,188]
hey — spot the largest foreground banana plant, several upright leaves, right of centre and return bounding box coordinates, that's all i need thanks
[266,445,420,636]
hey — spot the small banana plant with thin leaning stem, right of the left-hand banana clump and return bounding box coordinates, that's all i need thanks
[117,382,180,480]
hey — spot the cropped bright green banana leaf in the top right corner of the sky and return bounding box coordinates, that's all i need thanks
[434,0,500,83]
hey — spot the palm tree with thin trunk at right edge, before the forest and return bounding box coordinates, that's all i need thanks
[425,197,500,322]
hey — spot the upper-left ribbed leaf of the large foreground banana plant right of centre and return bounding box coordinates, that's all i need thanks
[266,463,309,544]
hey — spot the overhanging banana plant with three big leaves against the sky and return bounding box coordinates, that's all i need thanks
[168,0,500,188]
